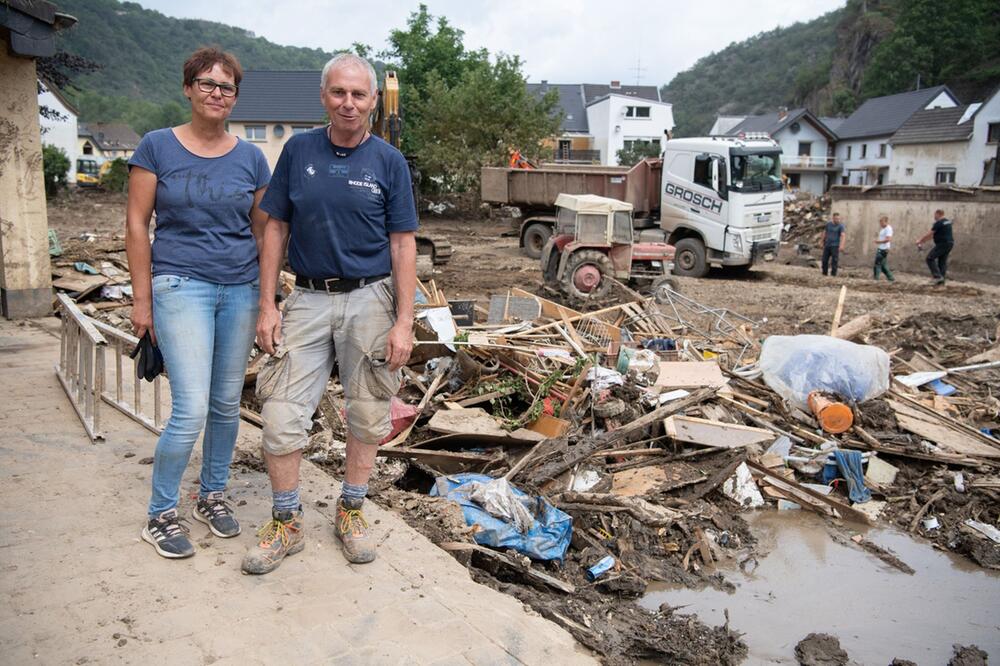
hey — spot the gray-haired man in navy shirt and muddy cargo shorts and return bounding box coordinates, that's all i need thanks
[243,54,417,574]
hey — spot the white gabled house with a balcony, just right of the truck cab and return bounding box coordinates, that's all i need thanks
[716,109,840,195]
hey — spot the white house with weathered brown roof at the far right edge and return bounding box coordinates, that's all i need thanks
[889,84,1000,187]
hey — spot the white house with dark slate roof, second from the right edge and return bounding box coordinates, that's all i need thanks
[836,86,958,185]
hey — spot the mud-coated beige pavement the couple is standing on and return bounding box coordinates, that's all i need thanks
[0,319,593,665]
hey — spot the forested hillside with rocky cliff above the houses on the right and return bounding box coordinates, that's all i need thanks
[662,0,1000,136]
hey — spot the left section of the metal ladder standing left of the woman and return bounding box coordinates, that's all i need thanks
[55,294,108,441]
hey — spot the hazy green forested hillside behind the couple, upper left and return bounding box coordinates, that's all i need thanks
[50,0,338,133]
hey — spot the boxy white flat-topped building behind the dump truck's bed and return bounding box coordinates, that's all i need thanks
[587,92,674,165]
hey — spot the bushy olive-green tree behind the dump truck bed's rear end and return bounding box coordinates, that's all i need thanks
[409,55,561,191]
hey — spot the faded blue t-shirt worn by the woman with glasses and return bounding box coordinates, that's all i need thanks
[128,127,271,284]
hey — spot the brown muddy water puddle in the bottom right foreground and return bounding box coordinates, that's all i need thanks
[639,511,1000,664]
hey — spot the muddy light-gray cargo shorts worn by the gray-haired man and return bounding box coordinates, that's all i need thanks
[257,278,402,455]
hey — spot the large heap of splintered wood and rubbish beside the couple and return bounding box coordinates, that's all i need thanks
[232,274,1000,664]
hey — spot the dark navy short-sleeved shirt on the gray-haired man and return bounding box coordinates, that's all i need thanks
[260,127,417,279]
